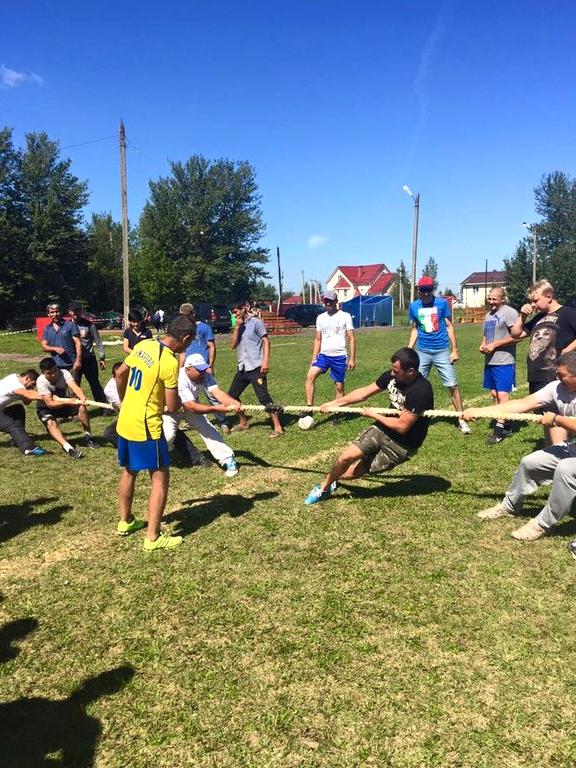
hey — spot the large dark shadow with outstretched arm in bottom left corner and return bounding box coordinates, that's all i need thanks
[0,665,134,768]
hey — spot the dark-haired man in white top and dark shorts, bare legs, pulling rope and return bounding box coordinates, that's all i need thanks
[36,357,98,459]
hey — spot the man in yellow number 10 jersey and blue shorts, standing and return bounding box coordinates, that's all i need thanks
[116,315,196,552]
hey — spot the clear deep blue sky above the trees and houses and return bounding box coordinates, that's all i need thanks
[0,0,576,290]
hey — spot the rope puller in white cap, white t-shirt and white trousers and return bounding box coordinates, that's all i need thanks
[162,352,243,477]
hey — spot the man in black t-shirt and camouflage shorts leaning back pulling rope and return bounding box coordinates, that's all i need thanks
[304,347,434,504]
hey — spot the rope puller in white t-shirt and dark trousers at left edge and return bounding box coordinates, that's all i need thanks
[0,368,46,456]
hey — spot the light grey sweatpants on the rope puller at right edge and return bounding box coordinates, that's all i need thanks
[503,443,576,528]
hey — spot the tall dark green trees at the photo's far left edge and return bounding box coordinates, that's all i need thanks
[0,129,88,319]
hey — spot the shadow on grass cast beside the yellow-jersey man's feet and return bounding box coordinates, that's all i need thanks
[164,491,279,536]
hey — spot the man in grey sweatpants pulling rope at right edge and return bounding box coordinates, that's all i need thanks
[463,352,576,541]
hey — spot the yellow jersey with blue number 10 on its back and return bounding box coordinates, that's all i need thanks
[117,339,178,441]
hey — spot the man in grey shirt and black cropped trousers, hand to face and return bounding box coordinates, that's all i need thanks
[228,305,284,437]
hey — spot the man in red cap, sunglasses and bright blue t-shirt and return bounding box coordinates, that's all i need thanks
[408,275,470,435]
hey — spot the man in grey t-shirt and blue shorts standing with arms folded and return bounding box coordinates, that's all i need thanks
[480,288,518,445]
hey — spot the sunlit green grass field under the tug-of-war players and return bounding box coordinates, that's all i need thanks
[0,326,576,768]
